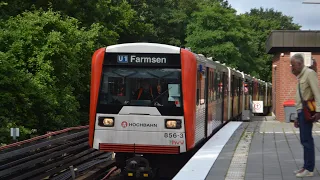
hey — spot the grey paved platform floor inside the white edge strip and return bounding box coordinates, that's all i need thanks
[206,116,320,180]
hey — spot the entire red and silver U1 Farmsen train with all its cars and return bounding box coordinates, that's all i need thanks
[89,43,272,177]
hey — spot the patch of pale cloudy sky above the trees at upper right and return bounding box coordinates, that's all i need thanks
[228,0,320,30]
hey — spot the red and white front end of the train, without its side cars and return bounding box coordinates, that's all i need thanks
[89,43,196,176]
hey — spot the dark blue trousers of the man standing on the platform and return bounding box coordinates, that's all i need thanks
[298,112,315,172]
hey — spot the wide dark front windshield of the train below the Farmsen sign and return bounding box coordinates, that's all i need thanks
[99,67,182,115]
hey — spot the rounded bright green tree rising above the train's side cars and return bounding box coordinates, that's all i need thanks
[186,2,254,72]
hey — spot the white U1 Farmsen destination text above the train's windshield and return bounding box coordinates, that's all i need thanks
[118,55,167,64]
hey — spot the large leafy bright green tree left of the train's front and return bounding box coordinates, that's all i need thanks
[0,10,106,143]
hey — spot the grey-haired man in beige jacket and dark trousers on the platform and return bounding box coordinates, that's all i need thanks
[291,54,320,177]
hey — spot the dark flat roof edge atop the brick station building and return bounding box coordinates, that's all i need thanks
[266,30,320,54]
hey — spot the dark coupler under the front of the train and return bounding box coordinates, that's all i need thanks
[122,156,154,179]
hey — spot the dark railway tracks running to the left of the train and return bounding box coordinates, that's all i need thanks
[0,126,114,180]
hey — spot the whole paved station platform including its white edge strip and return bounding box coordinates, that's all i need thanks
[173,116,320,180]
